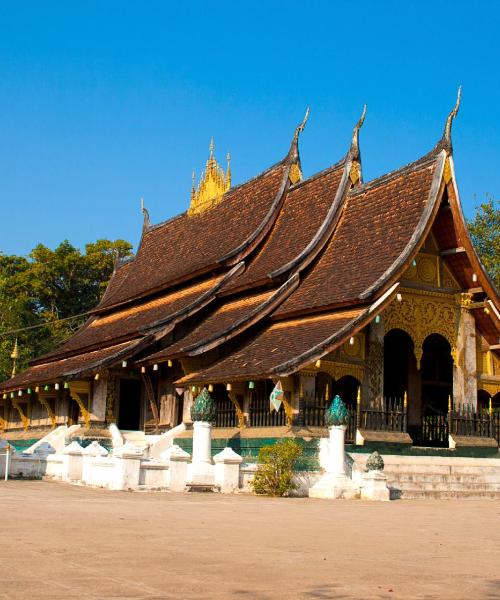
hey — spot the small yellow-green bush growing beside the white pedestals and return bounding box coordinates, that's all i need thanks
[252,440,303,496]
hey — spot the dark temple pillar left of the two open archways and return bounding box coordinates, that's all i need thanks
[362,316,385,408]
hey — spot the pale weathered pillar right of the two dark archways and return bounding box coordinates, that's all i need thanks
[453,306,477,409]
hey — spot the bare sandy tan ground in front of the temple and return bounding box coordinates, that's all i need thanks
[0,481,500,600]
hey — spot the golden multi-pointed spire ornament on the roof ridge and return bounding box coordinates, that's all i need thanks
[188,137,231,215]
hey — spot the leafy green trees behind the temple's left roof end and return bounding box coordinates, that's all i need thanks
[0,240,132,380]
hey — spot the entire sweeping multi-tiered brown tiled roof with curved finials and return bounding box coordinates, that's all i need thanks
[0,96,500,389]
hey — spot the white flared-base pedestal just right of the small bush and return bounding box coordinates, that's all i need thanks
[309,425,359,500]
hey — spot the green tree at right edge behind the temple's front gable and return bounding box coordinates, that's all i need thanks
[468,194,500,288]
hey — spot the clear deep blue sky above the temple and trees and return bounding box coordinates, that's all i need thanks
[0,0,500,254]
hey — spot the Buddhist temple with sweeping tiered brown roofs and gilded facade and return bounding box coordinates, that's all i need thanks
[0,90,500,449]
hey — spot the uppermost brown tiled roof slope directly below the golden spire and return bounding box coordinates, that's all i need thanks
[98,161,289,312]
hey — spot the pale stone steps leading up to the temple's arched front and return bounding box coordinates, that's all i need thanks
[351,453,500,500]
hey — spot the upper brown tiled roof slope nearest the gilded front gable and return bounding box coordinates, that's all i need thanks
[275,154,444,318]
